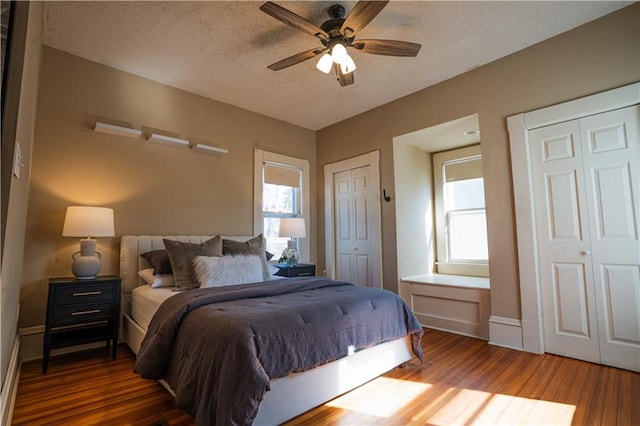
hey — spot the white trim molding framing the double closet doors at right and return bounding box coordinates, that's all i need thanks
[508,83,640,353]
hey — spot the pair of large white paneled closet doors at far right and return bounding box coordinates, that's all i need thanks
[529,106,640,371]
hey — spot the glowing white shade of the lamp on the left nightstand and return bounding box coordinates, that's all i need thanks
[62,206,115,237]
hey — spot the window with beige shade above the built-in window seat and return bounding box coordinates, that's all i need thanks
[433,145,489,277]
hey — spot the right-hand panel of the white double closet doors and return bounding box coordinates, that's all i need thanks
[580,106,640,371]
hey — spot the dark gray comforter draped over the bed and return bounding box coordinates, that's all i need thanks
[134,277,423,425]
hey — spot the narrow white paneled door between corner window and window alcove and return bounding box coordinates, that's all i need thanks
[333,166,380,287]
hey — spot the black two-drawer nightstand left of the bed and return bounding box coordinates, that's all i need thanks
[42,276,121,373]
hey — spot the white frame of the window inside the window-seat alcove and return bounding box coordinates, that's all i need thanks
[432,145,489,277]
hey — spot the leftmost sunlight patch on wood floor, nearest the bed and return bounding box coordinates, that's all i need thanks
[327,377,431,418]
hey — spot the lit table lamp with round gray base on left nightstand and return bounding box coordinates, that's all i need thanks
[62,206,115,280]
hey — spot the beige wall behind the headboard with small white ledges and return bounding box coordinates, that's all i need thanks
[20,47,317,327]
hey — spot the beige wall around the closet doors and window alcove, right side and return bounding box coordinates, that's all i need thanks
[317,3,640,318]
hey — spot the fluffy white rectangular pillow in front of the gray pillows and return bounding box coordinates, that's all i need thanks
[192,255,264,288]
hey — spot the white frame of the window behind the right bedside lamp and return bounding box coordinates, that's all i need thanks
[253,148,311,262]
